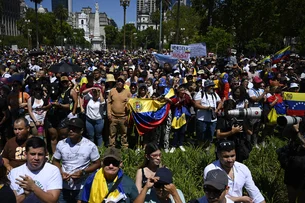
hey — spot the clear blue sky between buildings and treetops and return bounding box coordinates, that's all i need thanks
[25,0,137,28]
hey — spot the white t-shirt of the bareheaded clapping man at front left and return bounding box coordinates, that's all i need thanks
[8,163,62,203]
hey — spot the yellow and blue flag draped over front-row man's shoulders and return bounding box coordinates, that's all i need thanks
[81,169,127,203]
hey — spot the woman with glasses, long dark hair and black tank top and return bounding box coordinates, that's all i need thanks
[136,142,162,193]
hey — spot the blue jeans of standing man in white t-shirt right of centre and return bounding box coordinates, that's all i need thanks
[196,120,217,143]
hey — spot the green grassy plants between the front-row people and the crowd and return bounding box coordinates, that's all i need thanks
[101,138,288,203]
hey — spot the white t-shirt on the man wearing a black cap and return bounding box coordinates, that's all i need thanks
[53,137,100,190]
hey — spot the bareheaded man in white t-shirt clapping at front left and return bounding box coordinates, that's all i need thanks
[8,137,62,203]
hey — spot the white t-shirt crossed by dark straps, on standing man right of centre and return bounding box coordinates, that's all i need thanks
[194,91,220,122]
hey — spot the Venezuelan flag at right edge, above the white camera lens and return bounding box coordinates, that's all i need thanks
[283,92,305,116]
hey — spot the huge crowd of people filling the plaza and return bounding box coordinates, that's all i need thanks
[0,49,305,203]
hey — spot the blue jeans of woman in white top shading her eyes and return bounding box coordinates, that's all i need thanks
[86,117,104,147]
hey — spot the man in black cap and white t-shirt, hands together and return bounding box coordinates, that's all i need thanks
[53,118,101,203]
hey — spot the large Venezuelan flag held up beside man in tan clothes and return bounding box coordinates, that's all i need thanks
[128,98,170,135]
